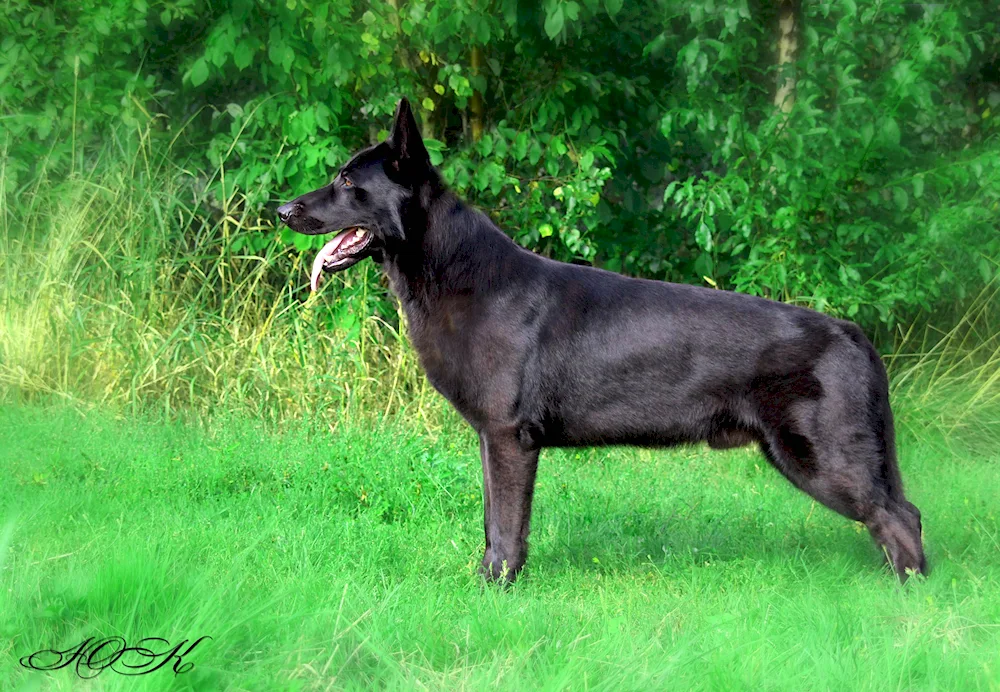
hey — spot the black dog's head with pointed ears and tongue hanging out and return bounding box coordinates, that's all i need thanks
[278,99,434,291]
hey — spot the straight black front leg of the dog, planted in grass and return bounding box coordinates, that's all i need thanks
[479,428,538,581]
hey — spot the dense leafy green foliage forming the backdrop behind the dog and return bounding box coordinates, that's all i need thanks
[0,0,1000,326]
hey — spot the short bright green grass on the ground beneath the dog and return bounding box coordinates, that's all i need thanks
[0,406,1000,690]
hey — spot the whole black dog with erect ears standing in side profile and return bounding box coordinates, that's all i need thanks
[278,99,926,580]
